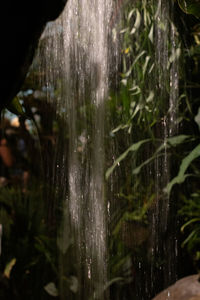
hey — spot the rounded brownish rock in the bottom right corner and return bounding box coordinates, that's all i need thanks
[152,275,200,300]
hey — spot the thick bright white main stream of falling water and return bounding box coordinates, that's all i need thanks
[40,0,112,299]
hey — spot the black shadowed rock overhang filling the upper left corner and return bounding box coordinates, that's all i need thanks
[0,0,67,110]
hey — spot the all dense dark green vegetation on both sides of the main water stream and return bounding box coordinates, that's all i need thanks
[0,0,200,300]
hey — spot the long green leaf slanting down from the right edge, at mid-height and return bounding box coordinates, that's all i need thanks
[165,144,200,194]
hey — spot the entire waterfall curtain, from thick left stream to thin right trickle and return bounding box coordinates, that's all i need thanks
[36,0,183,300]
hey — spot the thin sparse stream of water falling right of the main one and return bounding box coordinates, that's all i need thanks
[152,0,180,287]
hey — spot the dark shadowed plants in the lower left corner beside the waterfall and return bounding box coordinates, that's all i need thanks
[0,186,57,300]
